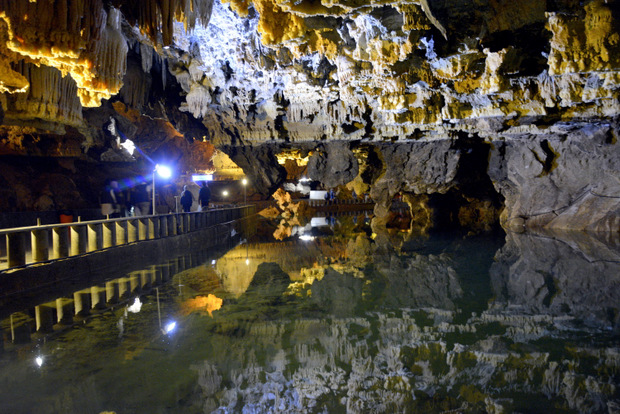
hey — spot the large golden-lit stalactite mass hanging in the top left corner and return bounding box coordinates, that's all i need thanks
[0,0,127,106]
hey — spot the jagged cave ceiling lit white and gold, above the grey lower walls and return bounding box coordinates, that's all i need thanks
[0,0,620,230]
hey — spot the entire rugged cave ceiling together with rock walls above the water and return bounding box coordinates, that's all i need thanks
[0,0,620,232]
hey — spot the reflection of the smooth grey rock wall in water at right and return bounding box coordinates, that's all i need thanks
[489,230,620,332]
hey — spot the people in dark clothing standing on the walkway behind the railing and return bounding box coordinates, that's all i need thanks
[99,180,211,218]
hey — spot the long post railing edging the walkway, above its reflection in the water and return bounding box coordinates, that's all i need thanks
[0,205,255,271]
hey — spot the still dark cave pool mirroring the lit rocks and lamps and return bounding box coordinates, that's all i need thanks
[0,218,620,414]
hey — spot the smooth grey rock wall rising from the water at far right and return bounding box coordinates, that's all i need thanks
[489,123,620,232]
